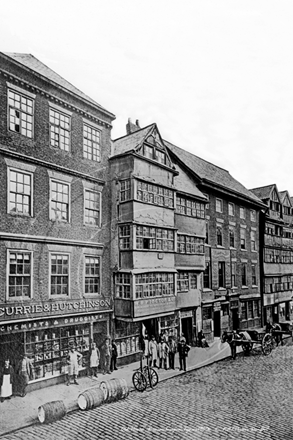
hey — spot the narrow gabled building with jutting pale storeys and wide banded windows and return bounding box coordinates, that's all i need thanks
[110,121,206,360]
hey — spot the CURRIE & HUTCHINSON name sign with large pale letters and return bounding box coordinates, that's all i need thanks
[0,299,112,320]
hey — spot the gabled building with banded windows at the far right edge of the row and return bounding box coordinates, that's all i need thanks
[251,184,293,323]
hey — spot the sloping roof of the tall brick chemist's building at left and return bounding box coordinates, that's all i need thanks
[2,52,114,117]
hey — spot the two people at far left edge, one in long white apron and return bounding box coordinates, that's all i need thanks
[0,354,34,402]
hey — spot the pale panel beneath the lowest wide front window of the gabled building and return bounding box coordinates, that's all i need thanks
[133,296,175,318]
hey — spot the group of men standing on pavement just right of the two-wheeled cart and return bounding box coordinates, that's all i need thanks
[142,331,190,371]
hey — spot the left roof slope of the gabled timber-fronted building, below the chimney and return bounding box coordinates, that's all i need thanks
[113,124,156,156]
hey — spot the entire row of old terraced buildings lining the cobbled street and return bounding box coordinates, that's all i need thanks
[0,53,293,389]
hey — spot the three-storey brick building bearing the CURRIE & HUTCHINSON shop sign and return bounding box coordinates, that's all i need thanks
[0,53,114,387]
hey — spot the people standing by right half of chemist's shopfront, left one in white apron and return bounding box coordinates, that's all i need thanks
[66,338,118,385]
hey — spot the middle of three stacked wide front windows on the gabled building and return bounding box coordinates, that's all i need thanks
[136,226,175,252]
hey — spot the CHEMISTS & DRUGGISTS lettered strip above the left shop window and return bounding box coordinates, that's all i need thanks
[0,315,103,333]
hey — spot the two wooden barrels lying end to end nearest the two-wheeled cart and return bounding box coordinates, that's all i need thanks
[78,379,129,410]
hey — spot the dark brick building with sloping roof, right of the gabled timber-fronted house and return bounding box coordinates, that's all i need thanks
[166,142,264,340]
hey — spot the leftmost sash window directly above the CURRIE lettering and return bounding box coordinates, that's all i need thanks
[8,251,32,300]
